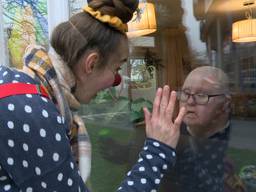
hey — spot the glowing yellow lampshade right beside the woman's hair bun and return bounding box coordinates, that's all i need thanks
[127,3,156,38]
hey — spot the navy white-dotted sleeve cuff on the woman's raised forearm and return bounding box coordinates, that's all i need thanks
[118,139,175,192]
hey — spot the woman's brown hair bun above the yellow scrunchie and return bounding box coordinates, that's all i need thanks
[87,0,139,23]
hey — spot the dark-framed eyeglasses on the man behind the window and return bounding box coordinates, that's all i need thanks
[177,91,225,105]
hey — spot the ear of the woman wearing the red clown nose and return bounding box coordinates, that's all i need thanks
[83,52,99,74]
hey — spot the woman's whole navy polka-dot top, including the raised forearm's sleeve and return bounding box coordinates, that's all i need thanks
[0,66,176,192]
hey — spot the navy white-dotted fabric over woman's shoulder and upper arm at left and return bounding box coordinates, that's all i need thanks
[0,67,90,192]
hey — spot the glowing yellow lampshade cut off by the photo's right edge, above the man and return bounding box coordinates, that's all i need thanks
[232,18,256,43]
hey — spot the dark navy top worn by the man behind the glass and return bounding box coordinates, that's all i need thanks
[159,126,230,192]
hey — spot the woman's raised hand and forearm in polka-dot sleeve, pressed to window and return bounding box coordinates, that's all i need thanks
[118,86,185,192]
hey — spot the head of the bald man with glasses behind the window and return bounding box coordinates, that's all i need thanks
[179,66,230,138]
